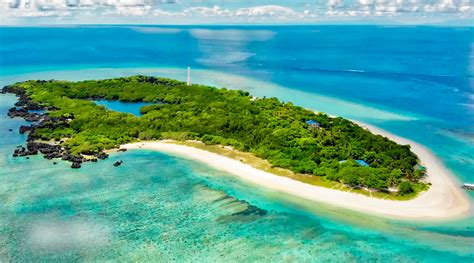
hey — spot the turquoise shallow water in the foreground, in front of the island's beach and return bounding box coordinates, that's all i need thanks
[0,78,474,262]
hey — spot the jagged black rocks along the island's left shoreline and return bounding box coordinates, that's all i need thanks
[0,84,114,169]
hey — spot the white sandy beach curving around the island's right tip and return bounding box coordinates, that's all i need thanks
[122,122,473,220]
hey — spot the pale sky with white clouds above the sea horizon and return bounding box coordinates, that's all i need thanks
[0,0,474,25]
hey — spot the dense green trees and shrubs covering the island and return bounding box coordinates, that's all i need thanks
[13,76,421,194]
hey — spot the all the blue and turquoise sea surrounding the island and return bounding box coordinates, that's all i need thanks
[0,25,474,262]
